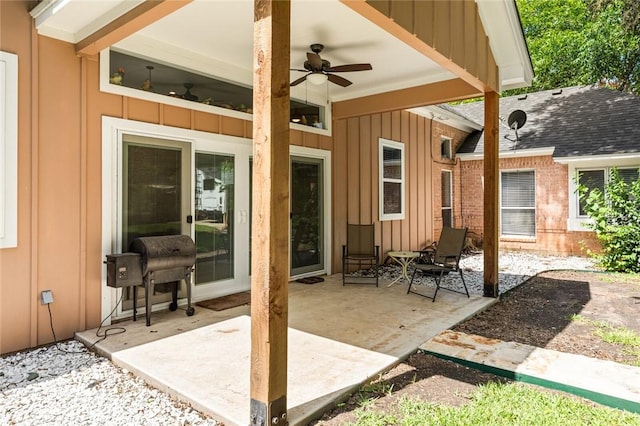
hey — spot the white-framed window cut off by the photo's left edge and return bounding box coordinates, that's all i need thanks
[0,52,18,249]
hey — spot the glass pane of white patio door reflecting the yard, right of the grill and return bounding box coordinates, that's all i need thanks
[195,152,235,285]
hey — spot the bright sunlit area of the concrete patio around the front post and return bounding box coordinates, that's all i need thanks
[113,316,396,425]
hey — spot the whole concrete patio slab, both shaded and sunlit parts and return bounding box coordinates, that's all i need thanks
[77,275,496,425]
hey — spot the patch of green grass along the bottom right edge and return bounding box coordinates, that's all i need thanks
[351,382,640,426]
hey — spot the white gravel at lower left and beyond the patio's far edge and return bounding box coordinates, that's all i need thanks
[0,253,594,426]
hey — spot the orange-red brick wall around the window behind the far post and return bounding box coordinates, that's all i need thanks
[456,155,598,255]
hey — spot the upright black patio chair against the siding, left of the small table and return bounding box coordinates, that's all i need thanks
[342,224,380,287]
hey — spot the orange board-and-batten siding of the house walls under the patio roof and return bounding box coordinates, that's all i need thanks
[0,1,480,353]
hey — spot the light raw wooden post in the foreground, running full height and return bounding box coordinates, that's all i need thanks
[250,0,291,426]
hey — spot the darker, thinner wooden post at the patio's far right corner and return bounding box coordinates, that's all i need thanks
[483,91,500,297]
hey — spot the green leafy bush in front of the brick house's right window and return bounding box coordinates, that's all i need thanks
[578,169,640,272]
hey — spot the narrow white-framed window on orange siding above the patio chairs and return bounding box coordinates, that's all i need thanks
[379,139,405,220]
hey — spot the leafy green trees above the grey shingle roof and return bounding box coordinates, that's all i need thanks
[505,0,640,95]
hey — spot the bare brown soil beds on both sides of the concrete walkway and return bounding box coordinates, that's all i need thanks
[311,271,640,425]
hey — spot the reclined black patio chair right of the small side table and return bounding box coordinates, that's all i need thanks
[407,226,469,302]
